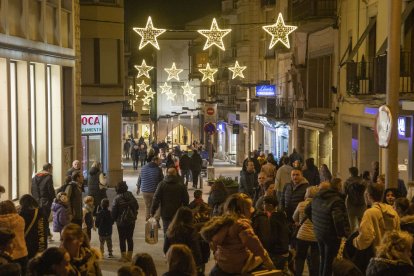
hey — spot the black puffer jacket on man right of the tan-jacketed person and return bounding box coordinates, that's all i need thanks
[305,189,350,240]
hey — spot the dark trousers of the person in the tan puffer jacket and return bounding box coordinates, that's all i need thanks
[295,239,320,276]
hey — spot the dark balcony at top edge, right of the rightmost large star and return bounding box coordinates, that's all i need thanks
[290,0,337,21]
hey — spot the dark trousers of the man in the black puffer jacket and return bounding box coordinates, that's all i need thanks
[318,238,341,276]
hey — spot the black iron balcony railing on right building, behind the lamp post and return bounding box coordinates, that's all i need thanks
[346,52,414,95]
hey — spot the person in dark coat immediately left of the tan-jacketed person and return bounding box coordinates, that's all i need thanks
[252,196,289,271]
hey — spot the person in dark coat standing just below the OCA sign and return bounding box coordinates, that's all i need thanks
[88,162,108,213]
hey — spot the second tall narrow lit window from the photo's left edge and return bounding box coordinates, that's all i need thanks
[29,63,37,176]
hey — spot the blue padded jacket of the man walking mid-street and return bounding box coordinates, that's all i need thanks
[137,162,164,193]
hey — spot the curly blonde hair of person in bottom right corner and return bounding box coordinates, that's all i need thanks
[377,230,413,264]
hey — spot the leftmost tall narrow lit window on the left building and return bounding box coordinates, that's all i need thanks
[10,61,19,199]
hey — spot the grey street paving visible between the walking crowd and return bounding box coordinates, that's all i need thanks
[51,160,241,275]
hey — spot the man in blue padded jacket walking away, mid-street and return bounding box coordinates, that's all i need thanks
[137,156,164,220]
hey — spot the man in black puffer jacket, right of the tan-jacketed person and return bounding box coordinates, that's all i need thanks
[305,178,350,276]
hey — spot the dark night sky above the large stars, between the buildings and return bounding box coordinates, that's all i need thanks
[125,0,221,30]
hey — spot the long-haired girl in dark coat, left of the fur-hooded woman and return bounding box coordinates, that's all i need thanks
[163,207,204,271]
